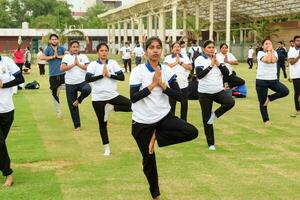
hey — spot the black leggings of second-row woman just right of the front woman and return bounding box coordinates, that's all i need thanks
[199,90,235,146]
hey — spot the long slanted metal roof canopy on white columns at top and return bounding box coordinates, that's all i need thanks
[98,0,300,22]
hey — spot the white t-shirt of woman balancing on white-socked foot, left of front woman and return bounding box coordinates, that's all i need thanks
[87,60,123,101]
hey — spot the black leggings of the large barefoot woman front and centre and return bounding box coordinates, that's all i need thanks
[132,113,198,198]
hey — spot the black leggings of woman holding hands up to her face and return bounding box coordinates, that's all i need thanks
[256,79,289,122]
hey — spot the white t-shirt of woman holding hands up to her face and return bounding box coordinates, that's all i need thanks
[256,51,278,80]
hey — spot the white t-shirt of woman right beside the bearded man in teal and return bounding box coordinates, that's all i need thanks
[61,54,90,85]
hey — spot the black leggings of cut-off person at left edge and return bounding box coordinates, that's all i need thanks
[0,111,14,176]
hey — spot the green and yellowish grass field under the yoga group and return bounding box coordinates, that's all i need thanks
[0,55,300,200]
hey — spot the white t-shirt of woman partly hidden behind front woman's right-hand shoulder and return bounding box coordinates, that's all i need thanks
[164,54,191,89]
